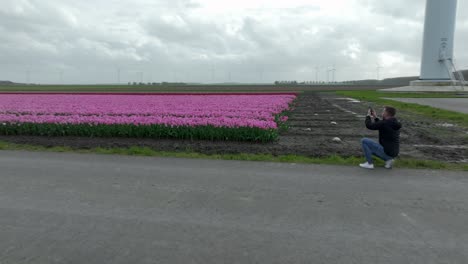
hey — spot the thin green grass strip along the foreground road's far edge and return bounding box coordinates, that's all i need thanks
[0,141,468,171]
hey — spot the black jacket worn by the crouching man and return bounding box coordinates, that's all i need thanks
[366,116,401,158]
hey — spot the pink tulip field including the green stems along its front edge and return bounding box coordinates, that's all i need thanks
[0,94,296,142]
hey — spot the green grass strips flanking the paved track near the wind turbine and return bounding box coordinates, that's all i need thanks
[336,91,468,127]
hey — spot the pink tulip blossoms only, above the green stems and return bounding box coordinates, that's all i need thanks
[0,94,296,129]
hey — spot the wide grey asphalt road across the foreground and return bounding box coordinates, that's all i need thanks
[0,152,468,264]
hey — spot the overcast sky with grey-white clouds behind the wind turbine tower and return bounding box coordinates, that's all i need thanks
[0,0,468,84]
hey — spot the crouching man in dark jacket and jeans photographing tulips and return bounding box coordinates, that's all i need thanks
[359,106,401,169]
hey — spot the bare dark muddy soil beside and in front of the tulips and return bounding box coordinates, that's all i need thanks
[0,92,468,162]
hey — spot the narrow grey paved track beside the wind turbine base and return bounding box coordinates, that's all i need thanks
[388,98,468,114]
